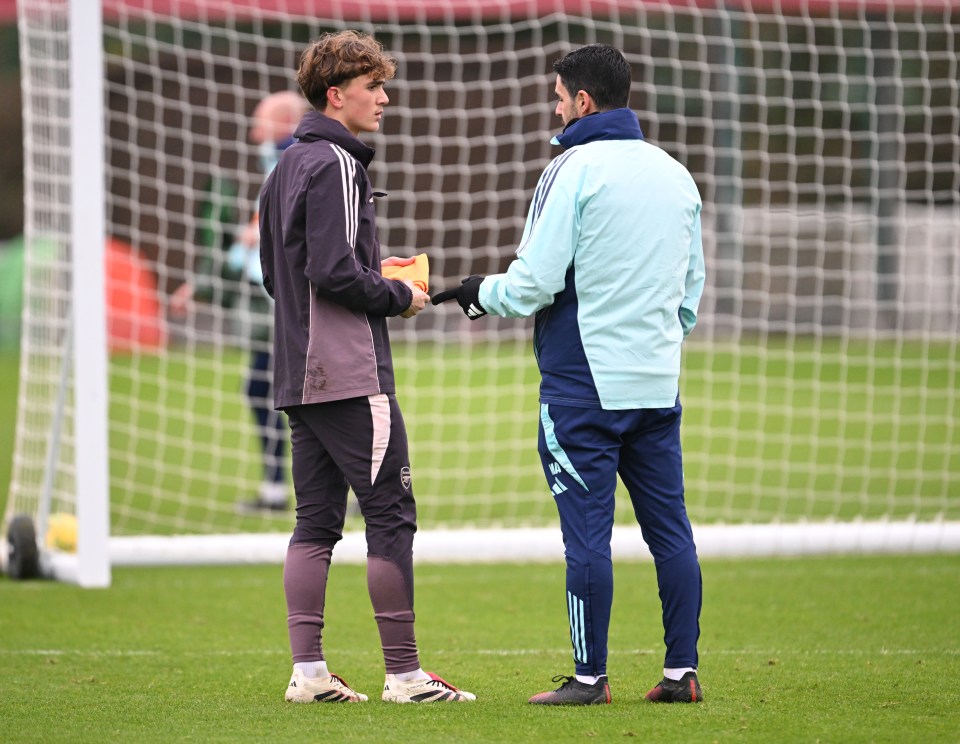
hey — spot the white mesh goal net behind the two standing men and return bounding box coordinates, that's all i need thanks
[6,0,960,580]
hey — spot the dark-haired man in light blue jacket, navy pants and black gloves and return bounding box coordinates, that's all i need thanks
[432,44,704,705]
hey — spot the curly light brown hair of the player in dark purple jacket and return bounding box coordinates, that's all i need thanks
[297,31,397,111]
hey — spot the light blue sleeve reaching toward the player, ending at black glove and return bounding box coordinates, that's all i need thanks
[479,150,580,318]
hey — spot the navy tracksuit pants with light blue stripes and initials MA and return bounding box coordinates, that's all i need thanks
[539,399,702,675]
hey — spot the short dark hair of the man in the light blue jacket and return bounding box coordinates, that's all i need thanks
[553,44,630,111]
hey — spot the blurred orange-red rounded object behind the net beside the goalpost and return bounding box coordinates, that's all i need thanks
[106,238,167,352]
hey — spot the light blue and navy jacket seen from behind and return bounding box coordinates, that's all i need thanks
[479,109,705,410]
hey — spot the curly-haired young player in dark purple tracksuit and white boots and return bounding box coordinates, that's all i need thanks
[260,31,475,703]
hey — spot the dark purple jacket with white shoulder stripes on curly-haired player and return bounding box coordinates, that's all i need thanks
[260,111,412,408]
